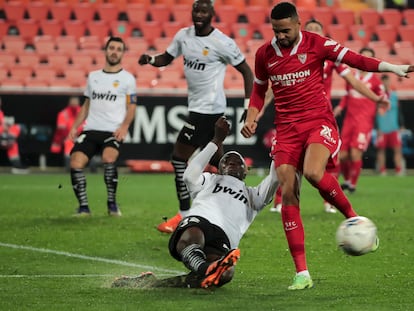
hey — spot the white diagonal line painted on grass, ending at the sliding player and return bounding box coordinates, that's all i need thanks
[0,242,183,276]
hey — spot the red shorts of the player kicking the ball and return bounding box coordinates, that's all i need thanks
[271,119,341,171]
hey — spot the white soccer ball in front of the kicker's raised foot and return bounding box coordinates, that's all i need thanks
[336,216,378,256]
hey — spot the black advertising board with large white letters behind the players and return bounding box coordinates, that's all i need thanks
[0,94,414,168]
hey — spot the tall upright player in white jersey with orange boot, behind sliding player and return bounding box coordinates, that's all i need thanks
[139,0,253,233]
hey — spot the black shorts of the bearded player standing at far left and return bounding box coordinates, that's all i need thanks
[71,131,122,159]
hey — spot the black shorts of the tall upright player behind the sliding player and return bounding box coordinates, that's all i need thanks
[177,112,223,148]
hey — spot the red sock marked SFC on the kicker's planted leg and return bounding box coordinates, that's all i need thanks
[282,205,308,272]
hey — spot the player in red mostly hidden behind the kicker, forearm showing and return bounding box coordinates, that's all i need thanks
[270,19,388,213]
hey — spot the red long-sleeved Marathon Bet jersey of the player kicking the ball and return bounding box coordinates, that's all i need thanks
[250,31,380,130]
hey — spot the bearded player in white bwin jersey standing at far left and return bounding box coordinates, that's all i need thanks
[69,37,137,216]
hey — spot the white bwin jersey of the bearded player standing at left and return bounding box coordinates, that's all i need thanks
[84,69,136,132]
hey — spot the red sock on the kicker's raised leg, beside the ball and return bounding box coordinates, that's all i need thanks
[314,172,357,218]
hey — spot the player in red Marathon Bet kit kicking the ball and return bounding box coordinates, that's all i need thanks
[241,2,414,290]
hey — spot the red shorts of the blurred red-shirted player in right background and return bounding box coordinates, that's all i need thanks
[341,123,372,151]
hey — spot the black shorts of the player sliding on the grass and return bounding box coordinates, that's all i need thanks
[168,216,230,261]
